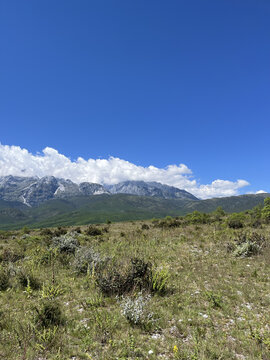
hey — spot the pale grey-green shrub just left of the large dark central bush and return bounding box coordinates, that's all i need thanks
[74,247,102,274]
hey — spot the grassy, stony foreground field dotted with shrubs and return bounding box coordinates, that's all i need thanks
[0,214,270,360]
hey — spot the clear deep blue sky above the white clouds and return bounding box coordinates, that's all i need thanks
[0,0,270,196]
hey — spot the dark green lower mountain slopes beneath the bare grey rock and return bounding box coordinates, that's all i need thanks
[0,194,270,229]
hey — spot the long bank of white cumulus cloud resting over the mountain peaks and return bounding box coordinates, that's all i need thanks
[0,144,249,199]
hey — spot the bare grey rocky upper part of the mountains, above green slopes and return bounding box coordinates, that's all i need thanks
[0,176,198,206]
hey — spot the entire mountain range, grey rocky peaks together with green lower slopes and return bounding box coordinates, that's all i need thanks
[0,176,270,230]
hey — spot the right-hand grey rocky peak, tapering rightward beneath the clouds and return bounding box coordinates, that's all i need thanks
[107,181,198,200]
